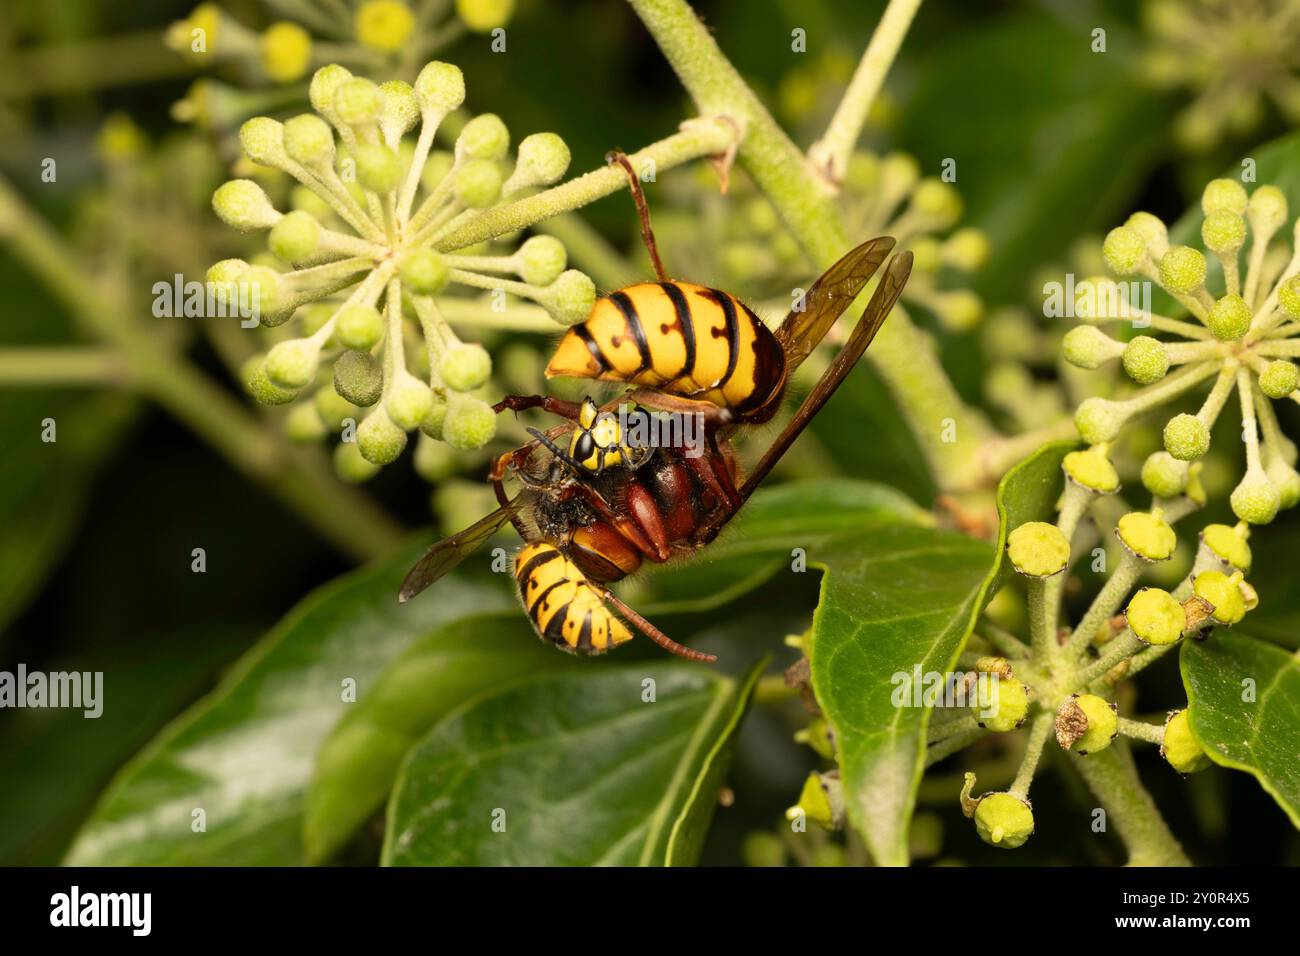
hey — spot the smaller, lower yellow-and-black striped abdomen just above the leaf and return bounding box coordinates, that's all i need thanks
[515,541,632,654]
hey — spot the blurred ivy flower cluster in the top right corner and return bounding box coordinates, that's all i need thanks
[1141,0,1300,151]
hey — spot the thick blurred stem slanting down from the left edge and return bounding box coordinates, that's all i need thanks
[0,179,400,559]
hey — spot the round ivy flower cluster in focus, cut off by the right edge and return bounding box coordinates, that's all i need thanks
[1063,179,1300,524]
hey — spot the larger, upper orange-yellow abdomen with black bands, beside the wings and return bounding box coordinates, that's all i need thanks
[546,282,785,412]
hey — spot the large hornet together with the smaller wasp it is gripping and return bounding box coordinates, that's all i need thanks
[398,152,911,662]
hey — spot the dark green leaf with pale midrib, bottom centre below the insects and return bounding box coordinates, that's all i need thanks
[384,661,766,866]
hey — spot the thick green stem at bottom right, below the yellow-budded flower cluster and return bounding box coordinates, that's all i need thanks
[1071,740,1191,866]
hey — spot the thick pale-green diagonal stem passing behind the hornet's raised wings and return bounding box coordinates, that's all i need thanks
[628,0,996,490]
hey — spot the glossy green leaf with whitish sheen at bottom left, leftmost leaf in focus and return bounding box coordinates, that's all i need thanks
[68,549,514,866]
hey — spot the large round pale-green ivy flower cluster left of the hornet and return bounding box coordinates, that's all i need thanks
[208,61,595,480]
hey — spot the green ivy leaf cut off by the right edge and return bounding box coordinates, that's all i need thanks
[1179,628,1300,829]
